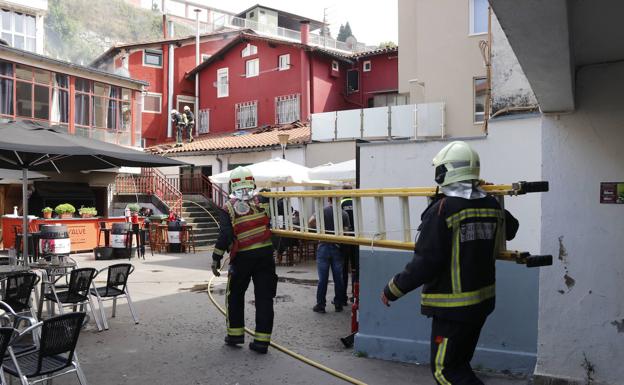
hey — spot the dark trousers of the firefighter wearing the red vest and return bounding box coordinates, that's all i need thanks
[226,246,277,344]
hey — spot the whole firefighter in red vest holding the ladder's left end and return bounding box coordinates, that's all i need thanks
[212,167,277,354]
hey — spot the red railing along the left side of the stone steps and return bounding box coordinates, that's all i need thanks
[115,168,182,215]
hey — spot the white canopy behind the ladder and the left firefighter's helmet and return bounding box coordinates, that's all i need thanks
[209,158,331,187]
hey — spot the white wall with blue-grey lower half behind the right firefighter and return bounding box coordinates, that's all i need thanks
[355,118,542,373]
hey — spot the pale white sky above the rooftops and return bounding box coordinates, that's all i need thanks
[149,0,398,45]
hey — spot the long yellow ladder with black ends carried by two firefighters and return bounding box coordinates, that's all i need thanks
[260,182,552,267]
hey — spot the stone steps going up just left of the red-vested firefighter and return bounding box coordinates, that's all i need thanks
[182,196,219,247]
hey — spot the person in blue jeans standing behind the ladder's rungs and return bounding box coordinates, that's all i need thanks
[309,198,351,313]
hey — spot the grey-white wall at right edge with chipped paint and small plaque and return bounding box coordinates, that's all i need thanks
[536,63,624,385]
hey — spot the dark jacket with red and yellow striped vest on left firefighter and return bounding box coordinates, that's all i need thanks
[212,197,272,260]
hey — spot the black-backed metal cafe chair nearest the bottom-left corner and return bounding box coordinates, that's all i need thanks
[3,312,87,385]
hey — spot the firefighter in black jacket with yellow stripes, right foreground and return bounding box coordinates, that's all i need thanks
[381,141,518,385]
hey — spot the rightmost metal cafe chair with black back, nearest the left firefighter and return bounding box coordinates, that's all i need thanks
[91,263,139,330]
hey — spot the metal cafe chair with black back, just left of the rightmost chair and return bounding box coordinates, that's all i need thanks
[45,267,102,331]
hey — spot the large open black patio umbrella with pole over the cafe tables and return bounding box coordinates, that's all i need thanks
[0,120,186,255]
